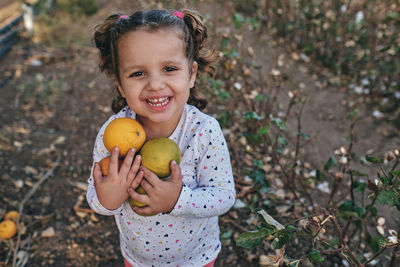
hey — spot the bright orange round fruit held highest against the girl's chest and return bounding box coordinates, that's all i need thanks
[103,118,146,158]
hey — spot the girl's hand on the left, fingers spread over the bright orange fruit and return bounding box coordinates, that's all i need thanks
[93,147,143,210]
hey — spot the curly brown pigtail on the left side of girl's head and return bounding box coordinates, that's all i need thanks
[93,14,127,113]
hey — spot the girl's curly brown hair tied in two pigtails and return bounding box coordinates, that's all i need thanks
[94,9,217,113]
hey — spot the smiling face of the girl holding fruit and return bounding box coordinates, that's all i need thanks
[118,29,197,134]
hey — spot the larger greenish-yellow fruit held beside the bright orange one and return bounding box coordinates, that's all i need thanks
[139,137,181,178]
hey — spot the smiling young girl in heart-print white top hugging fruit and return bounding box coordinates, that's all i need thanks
[87,10,235,267]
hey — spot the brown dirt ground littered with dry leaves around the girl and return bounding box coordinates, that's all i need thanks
[0,0,399,267]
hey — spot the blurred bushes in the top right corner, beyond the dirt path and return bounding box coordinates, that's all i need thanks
[257,0,400,125]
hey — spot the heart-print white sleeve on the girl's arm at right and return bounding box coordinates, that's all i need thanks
[171,117,236,218]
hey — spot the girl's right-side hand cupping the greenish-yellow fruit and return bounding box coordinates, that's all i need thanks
[128,161,183,215]
